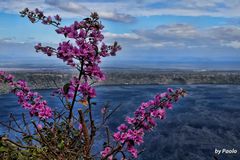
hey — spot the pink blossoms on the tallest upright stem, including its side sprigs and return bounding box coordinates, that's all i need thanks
[21,9,121,101]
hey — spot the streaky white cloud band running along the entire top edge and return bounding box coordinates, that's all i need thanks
[0,0,240,22]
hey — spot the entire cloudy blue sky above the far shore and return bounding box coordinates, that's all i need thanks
[0,0,240,69]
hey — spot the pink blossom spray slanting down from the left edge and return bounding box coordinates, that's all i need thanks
[0,71,52,119]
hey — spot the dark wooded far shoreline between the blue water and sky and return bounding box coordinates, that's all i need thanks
[1,69,240,92]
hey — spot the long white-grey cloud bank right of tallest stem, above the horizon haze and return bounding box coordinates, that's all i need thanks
[104,24,240,50]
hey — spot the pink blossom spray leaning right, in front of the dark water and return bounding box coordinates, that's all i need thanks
[108,88,185,158]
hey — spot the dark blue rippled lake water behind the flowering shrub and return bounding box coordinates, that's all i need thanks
[0,85,240,160]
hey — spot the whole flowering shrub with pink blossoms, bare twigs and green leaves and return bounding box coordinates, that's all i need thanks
[0,8,185,160]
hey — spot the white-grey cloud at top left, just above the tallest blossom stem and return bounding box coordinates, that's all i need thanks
[0,0,135,23]
